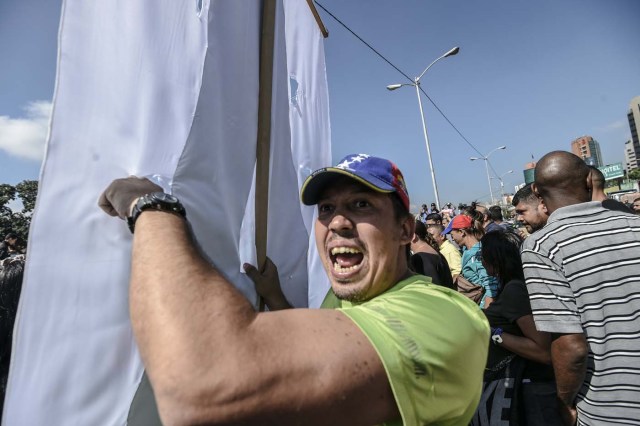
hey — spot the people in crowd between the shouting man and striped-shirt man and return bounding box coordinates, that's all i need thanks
[418,205,563,425]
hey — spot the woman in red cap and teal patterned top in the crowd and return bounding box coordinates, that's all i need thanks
[445,210,498,308]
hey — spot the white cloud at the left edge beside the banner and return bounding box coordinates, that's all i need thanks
[0,101,52,161]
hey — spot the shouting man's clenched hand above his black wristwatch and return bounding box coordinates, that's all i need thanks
[98,176,162,219]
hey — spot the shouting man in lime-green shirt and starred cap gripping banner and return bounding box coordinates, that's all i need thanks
[100,154,489,425]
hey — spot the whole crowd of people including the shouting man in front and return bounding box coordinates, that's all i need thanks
[0,151,640,426]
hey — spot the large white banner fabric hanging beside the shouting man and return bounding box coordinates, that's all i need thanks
[3,0,330,425]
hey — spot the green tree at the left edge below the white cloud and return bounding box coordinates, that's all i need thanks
[0,180,38,242]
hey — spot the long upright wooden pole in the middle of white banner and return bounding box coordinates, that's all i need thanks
[255,0,276,311]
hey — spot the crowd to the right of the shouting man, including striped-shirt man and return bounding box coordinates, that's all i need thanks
[416,152,640,425]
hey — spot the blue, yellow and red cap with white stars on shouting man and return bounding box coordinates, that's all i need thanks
[300,154,409,211]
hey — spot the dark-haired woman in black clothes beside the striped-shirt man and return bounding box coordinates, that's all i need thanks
[472,232,561,425]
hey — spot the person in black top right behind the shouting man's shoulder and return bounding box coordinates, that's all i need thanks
[410,220,455,289]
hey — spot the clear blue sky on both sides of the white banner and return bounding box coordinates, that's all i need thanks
[0,0,640,205]
